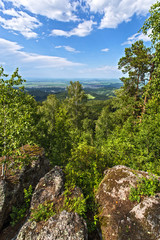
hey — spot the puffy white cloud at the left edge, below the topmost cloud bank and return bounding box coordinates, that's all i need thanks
[0,9,42,38]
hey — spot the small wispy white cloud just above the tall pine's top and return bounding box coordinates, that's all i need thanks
[122,30,151,45]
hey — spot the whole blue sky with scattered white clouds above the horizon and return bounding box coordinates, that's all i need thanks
[0,0,156,79]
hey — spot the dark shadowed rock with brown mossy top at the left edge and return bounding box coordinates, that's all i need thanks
[0,145,50,230]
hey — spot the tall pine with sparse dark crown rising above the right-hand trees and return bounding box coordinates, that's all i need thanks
[117,41,152,116]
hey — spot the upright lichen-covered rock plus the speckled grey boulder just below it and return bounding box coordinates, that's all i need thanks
[16,167,88,240]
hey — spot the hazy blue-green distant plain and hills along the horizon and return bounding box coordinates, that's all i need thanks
[25,79,122,102]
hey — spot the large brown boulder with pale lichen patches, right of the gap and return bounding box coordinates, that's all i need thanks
[96,166,160,240]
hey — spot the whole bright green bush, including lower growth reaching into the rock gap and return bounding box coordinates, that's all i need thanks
[65,142,107,231]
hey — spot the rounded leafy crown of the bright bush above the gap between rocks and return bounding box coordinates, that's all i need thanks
[65,143,105,197]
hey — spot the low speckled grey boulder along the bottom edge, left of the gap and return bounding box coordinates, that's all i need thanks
[16,210,88,240]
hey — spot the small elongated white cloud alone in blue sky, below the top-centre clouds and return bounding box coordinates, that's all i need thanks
[51,20,96,37]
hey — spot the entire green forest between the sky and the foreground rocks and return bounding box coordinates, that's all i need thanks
[0,3,160,238]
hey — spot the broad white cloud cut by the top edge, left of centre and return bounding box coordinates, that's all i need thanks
[4,0,77,22]
